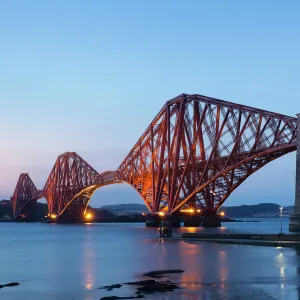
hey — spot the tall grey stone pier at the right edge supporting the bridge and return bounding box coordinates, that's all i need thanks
[289,114,300,232]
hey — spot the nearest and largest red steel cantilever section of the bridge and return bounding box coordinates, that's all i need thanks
[118,94,297,214]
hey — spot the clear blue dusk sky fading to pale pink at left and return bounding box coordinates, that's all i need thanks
[0,0,300,206]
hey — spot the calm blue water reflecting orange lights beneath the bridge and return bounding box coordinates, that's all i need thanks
[0,219,300,300]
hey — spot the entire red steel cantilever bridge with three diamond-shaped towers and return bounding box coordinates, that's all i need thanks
[11,94,297,225]
